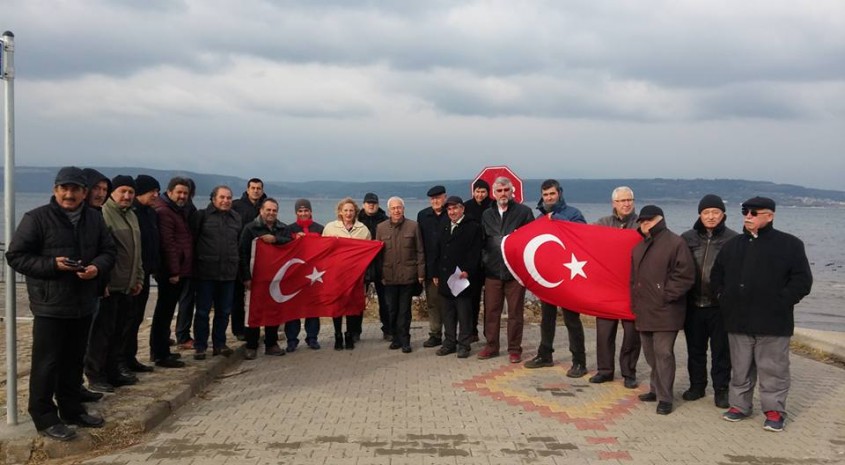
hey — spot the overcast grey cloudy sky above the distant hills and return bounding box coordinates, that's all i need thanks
[0,0,845,190]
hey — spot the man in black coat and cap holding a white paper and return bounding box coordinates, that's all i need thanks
[433,195,482,358]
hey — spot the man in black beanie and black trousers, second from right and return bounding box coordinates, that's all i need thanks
[681,194,737,408]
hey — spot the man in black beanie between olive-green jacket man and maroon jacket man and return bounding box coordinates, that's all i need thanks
[123,174,161,373]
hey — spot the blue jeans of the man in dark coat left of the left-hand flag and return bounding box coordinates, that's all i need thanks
[194,279,235,352]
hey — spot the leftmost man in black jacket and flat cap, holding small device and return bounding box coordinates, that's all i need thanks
[6,166,116,441]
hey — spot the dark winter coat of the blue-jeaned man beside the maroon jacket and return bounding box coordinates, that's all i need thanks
[191,202,243,281]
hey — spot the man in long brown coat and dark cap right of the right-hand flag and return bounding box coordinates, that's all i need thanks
[631,205,695,415]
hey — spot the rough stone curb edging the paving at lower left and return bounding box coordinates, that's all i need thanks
[0,344,245,465]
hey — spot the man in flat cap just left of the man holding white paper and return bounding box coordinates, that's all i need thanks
[417,185,449,347]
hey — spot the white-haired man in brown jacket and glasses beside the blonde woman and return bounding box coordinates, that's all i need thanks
[376,197,425,354]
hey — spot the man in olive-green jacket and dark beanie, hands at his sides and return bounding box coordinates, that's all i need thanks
[85,175,144,392]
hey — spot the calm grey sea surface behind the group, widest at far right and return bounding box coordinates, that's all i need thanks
[0,193,845,331]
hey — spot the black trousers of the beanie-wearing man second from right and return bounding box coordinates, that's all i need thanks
[684,306,731,391]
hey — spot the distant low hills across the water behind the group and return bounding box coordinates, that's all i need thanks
[0,166,845,206]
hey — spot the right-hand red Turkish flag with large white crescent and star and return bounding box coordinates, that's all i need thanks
[502,217,642,320]
